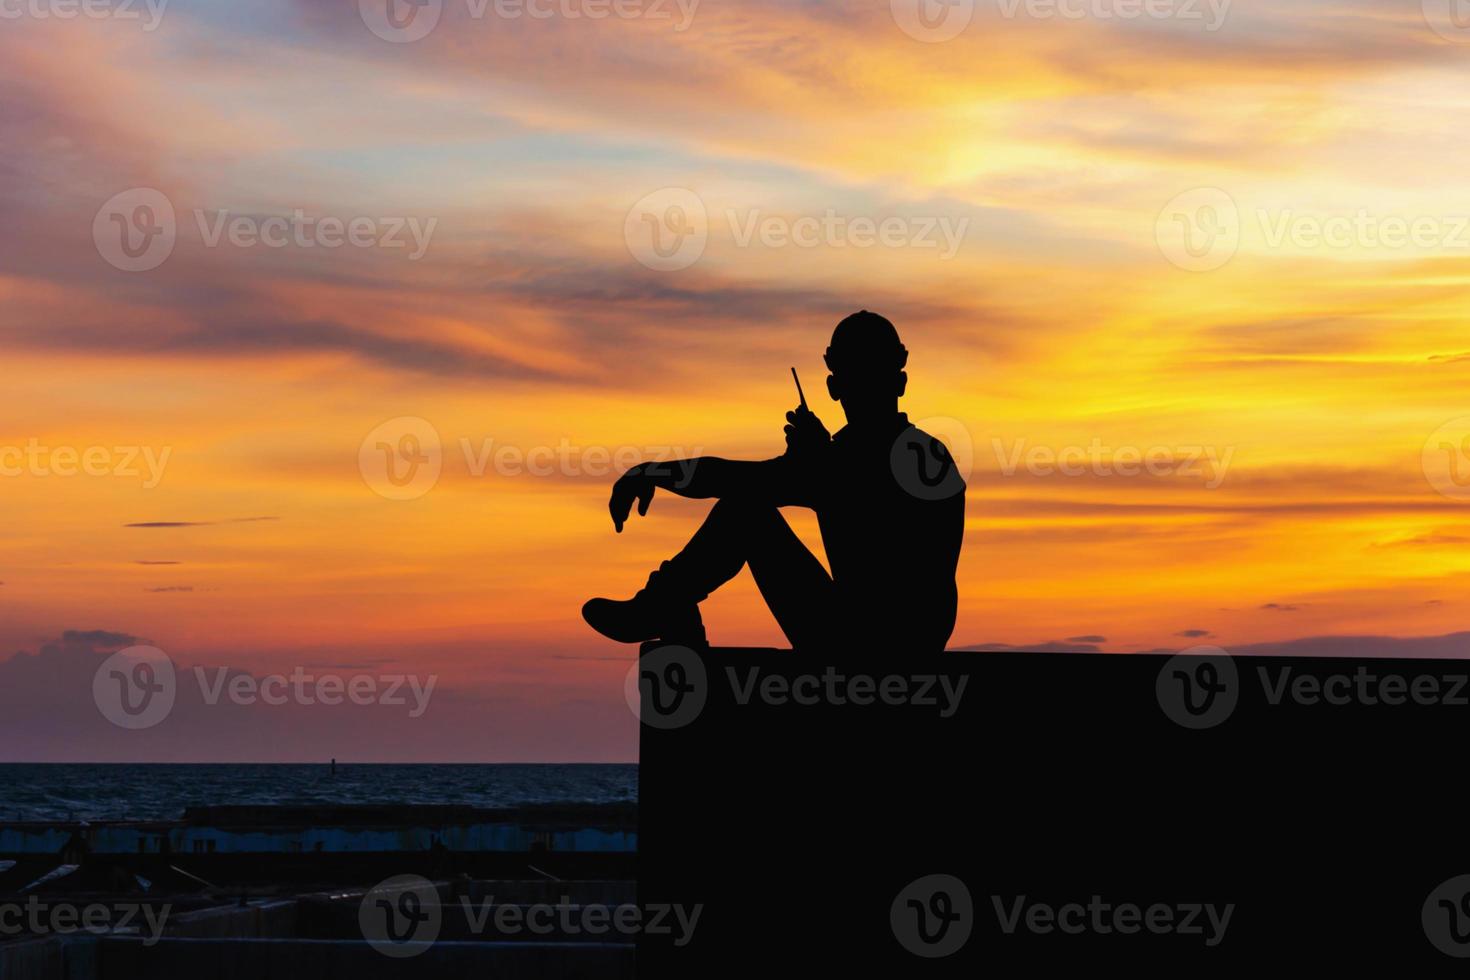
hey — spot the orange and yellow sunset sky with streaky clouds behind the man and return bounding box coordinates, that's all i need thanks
[0,0,1470,761]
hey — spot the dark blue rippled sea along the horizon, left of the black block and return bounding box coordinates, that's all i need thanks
[0,763,638,820]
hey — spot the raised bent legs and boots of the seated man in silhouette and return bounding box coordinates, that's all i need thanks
[582,498,832,646]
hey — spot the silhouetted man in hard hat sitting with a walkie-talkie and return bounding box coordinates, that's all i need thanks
[582,310,964,652]
